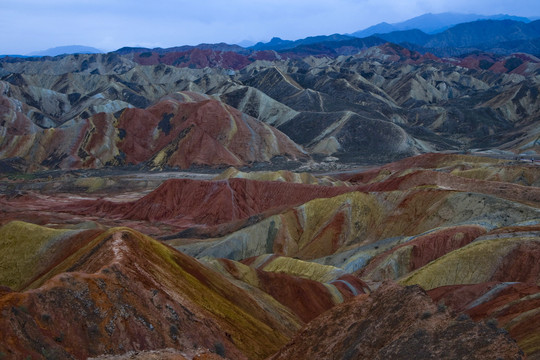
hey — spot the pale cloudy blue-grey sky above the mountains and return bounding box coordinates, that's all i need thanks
[0,0,540,55]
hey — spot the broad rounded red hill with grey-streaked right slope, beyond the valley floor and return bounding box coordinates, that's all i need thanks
[117,93,307,168]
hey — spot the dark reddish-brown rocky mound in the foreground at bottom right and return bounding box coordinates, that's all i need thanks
[270,283,524,359]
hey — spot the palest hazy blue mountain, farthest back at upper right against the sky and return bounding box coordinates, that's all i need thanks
[351,13,531,37]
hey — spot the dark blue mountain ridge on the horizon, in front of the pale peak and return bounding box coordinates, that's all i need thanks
[115,14,540,58]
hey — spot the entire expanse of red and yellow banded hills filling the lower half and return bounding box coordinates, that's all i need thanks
[0,154,540,359]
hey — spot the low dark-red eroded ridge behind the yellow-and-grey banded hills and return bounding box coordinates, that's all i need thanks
[69,178,354,231]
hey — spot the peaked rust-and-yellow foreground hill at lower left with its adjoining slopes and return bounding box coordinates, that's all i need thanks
[0,222,367,359]
